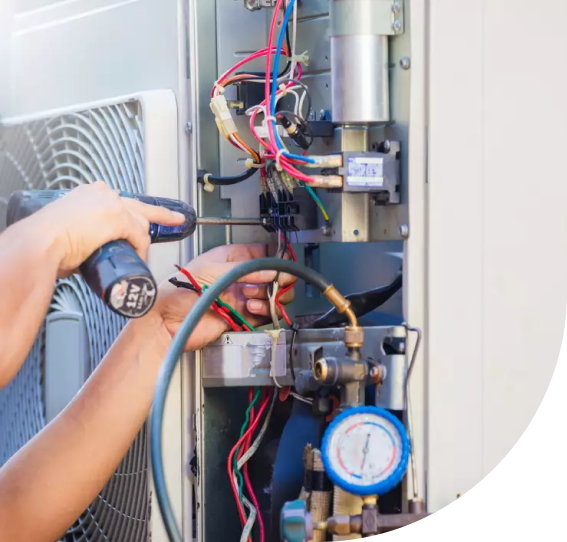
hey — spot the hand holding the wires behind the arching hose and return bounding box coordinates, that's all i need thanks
[156,245,295,350]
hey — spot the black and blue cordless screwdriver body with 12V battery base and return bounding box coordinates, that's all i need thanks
[6,190,197,318]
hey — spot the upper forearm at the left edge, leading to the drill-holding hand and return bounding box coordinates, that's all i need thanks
[0,217,61,388]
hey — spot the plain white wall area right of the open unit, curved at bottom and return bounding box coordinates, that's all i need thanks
[427,0,567,511]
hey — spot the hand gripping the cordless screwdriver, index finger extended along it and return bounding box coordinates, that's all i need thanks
[27,181,185,277]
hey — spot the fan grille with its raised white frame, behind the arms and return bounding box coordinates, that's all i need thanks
[0,90,182,542]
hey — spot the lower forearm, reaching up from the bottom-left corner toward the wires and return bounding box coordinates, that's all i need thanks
[0,312,175,542]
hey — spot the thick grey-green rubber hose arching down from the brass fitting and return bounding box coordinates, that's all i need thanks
[150,258,342,542]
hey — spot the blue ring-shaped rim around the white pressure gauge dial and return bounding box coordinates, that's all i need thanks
[321,406,411,497]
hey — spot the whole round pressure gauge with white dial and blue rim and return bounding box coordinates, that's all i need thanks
[322,407,410,497]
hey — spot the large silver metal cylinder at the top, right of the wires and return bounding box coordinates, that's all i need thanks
[330,0,390,124]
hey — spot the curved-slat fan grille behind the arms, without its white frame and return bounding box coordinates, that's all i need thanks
[0,101,150,542]
